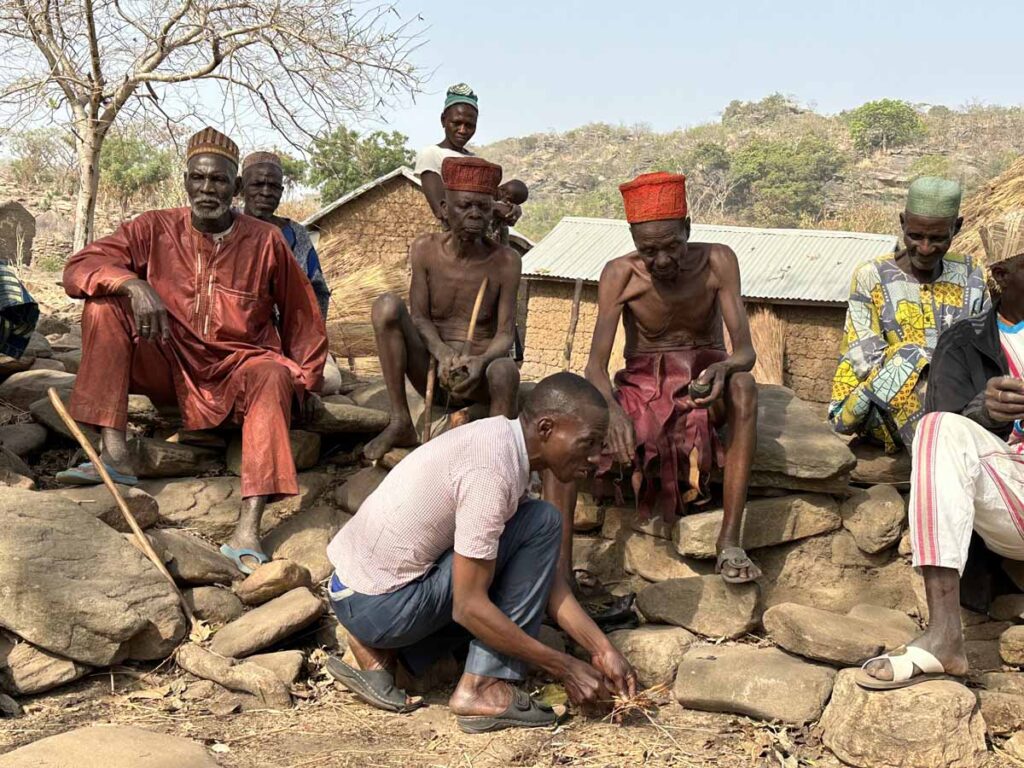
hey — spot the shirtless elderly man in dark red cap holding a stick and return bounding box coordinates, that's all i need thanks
[364,158,522,461]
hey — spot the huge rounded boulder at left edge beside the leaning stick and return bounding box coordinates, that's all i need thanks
[0,488,185,666]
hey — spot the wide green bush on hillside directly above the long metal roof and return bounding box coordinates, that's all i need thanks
[730,135,845,226]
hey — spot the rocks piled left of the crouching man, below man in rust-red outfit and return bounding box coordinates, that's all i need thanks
[0,321,387,712]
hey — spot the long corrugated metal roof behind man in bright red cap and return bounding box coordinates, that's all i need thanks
[522,216,897,303]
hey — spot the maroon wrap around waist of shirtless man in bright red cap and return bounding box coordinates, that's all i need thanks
[597,347,727,522]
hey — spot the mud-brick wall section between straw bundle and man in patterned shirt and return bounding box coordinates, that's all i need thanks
[772,304,846,405]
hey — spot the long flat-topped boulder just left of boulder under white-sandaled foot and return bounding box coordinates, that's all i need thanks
[675,645,836,724]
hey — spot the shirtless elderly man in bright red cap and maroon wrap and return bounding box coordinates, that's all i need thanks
[545,173,761,584]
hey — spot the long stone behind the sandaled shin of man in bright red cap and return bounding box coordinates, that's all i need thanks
[672,495,843,558]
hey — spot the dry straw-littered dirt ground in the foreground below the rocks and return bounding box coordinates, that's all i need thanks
[0,669,1020,768]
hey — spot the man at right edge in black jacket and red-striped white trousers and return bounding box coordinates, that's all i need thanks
[857,211,1024,689]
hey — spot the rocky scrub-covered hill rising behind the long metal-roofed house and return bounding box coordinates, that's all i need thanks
[479,94,1024,238]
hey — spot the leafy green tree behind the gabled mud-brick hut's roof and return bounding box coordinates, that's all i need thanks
[307,126,416,205]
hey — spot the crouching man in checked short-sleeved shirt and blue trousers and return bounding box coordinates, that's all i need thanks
[328,373,636,733]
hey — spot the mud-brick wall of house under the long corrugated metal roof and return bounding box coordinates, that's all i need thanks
[522,279,846,403]
